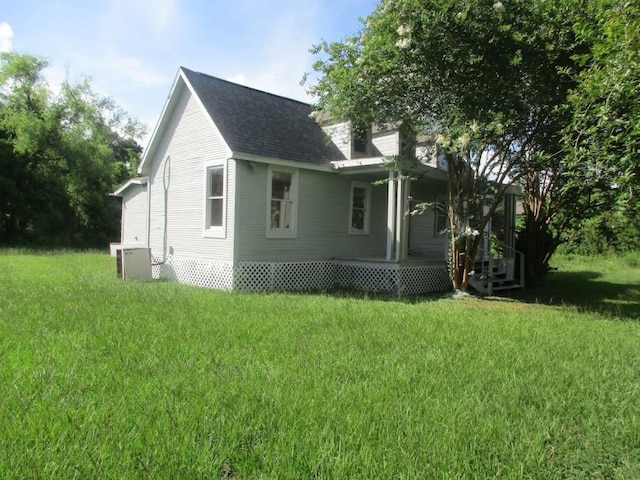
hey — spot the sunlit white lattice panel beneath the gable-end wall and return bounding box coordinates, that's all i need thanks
[159,255,233,290]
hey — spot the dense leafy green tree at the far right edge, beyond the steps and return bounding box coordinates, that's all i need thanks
[521,0,640,278]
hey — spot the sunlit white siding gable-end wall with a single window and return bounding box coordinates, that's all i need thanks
[149,88,235,262]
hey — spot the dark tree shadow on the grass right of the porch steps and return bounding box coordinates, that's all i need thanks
[504,271,640,320]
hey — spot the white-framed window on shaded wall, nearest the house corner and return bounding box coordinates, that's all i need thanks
[267,165,298,238]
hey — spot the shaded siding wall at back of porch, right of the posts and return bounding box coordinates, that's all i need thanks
[409,182,449,261]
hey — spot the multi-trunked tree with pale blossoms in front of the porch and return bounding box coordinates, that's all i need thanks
[309,0,581,290]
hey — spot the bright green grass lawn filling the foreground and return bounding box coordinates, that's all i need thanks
[0,252,640,479]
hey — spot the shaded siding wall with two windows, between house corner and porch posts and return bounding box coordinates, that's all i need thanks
[235,162,387,262]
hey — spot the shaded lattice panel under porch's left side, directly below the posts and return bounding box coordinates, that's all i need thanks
[336,261,400,292]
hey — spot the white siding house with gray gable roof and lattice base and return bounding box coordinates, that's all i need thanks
[114,68,520,293]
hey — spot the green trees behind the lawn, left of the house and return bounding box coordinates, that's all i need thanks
[0,53,142,246]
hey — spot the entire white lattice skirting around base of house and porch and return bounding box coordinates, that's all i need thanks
[152,255,451,294]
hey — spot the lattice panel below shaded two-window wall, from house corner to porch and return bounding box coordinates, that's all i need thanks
[234,261,335,291]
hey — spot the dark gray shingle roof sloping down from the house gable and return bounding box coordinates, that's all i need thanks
[182,67,344,164]
